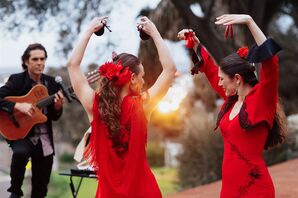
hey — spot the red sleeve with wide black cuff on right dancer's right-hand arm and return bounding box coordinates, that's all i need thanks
[240,39,281,128]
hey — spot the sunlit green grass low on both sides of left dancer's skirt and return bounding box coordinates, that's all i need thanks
[47,167,179,198]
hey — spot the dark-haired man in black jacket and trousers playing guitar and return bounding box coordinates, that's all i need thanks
[0,43,63,198]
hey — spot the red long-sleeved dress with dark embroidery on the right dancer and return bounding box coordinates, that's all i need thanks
[200,44,278,198]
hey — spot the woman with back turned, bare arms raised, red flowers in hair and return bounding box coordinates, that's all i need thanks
[67,17,176,198]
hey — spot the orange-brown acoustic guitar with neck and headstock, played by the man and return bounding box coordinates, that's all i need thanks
[0,71,99,140]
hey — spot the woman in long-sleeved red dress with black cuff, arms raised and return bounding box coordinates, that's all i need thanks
[178,14,286,198]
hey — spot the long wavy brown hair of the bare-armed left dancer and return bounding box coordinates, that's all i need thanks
[98,53,141,155]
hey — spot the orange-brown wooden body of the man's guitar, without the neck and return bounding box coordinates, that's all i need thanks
[0,84,49,140]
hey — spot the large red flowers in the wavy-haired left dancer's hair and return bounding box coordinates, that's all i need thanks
[98,61,132,87]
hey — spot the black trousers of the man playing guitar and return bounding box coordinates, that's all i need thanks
[7,139,53,198]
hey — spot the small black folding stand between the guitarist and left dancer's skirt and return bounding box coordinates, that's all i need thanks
[59,169,97,198]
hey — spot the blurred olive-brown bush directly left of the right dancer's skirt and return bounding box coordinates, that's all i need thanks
[178,110,223,188]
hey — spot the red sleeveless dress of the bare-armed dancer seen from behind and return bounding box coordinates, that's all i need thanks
[85,95,162,198]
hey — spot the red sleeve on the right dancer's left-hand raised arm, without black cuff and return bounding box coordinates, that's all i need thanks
[198,47,226,99]
